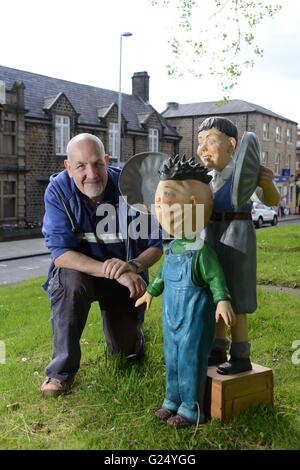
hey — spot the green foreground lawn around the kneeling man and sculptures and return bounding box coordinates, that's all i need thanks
[0,276,300,450]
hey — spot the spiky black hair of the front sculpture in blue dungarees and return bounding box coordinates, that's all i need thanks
[158,155,212,184]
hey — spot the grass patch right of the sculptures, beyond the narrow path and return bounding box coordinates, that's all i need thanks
[256,224,300,287]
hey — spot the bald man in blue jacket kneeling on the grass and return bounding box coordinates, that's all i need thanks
[41,134,162,396]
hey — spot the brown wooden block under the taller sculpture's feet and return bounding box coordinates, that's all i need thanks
[205,363,273,421]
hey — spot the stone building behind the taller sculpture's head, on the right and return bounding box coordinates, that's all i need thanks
[162,100,297,213]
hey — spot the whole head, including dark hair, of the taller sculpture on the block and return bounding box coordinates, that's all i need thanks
[197,117,238,171]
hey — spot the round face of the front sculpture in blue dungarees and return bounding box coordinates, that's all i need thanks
[155,180,213,238]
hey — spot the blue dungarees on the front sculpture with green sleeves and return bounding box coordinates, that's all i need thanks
[162,243,215,423]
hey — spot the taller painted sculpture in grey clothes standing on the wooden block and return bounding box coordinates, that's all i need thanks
[197,117,279,375]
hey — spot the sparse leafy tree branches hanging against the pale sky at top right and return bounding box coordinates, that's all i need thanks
[149,0,281,99]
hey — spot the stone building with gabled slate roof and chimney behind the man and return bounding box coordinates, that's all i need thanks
[0,66,180,225]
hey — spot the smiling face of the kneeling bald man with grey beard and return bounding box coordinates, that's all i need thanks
[64,140,108,199]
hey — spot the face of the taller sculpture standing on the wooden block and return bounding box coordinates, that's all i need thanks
[197,127,236,171]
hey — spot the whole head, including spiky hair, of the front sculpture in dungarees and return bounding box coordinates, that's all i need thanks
[155,155,213,238]
